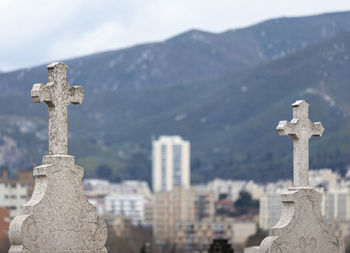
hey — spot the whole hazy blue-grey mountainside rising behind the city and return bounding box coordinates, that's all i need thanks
[0,12,350,182]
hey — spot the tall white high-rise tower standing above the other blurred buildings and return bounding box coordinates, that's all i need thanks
[152,136,190,192]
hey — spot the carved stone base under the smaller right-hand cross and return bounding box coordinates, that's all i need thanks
[259,187,345,253]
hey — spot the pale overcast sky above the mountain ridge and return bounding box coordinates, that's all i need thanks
[0,0,350,71]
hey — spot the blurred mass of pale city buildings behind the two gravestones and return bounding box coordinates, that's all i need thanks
[0,136,350,252]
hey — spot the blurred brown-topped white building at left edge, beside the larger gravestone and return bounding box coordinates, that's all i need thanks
[0,170,34,218]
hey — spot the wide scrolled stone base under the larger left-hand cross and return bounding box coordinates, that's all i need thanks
[9,155,107,253]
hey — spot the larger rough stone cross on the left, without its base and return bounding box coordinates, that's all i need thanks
[31,62,84,155]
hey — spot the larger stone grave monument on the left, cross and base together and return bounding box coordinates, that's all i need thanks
[9,63,107,253]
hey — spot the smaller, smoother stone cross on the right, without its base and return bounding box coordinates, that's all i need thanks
[277,100,324,187]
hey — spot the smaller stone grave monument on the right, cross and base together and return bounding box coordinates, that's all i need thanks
[259,100,345,253]
